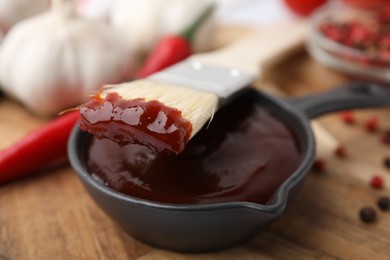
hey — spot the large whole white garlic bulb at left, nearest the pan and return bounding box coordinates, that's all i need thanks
[0,0,132,116]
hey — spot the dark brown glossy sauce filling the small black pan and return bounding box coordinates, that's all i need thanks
[87,95,300,204]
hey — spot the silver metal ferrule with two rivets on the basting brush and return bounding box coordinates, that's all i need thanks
[149,59,255,99]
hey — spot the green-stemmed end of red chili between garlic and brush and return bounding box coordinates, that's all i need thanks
[135,4,215,78]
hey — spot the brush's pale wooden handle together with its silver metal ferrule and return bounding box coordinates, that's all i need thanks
[149,20,307,99]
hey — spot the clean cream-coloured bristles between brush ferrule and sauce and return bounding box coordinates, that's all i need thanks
[100,80,219,138]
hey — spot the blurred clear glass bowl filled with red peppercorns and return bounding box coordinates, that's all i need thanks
[307,3,390,84]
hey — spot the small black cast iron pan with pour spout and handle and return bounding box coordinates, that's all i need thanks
[68,83,390,252]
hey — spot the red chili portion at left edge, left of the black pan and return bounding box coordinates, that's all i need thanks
[0,111,79,183]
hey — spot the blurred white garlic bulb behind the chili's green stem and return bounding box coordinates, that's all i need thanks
[109,0,214,57]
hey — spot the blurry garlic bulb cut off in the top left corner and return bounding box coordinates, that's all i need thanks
[0,0,50,32]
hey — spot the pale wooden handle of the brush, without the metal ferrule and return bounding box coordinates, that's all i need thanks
[190,20,307,76]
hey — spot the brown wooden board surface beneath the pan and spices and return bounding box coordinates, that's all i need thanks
[0,25,390,260]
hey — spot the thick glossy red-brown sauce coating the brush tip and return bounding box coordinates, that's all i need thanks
[79,93,192,153]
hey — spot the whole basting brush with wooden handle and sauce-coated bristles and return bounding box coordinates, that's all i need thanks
[79,22,306,153]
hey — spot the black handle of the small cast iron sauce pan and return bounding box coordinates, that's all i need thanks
[287,82,390,118]
